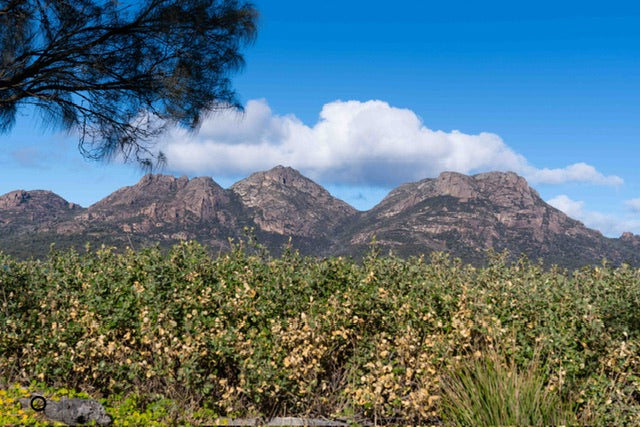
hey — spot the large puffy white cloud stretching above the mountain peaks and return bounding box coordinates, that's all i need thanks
[162,100,622,187]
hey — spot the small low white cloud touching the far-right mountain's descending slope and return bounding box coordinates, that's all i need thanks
[547,194,640,237]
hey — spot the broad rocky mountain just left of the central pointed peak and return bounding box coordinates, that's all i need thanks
[67,174,246,248]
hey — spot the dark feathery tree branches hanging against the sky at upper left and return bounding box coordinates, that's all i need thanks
[0,0,257,166]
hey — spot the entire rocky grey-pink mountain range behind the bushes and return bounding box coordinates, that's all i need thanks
[0,166,640,268]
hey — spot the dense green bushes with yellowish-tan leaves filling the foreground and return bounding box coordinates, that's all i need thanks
[0,243,640,424]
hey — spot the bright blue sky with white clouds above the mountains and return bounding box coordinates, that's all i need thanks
[0,0,640,237]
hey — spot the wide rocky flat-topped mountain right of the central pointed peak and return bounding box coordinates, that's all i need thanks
[335,172,629,266]
